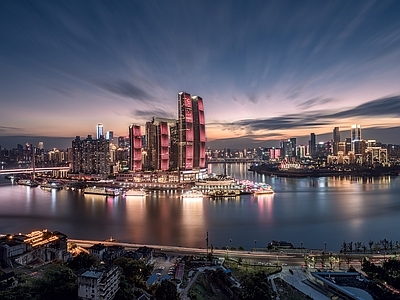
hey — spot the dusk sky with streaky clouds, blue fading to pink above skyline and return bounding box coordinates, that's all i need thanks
[0,0,400,149]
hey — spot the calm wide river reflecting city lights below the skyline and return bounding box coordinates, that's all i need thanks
[0,164,400,251]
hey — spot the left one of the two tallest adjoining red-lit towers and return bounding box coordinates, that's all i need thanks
[178,92,194,170]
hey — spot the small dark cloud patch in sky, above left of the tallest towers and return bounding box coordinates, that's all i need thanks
[96,79,153,102]
